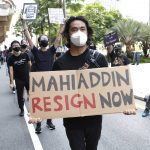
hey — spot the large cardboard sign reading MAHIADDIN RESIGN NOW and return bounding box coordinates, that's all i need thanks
[29,66,135,118]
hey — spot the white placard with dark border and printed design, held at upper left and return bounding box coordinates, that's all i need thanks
[22,3,38,20]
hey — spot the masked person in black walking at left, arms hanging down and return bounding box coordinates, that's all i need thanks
[8,40,31,116]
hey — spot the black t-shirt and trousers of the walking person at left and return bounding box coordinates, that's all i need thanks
[8,53,30,112]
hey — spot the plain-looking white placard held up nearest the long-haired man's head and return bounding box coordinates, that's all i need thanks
[48,8,64,24]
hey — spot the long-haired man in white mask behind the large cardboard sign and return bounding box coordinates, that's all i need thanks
[52,16,135,150]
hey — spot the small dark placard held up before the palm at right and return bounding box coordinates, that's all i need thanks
[104,32,119,47]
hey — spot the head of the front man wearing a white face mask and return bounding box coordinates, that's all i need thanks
[62,16,93,47]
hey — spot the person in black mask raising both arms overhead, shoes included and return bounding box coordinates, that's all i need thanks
[21,19,63,134]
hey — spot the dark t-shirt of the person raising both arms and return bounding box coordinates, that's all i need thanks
[31,46,56,71]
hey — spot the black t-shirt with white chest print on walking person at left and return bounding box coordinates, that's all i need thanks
[8,53,30,81]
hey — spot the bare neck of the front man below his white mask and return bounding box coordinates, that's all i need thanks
[70,45,87,56]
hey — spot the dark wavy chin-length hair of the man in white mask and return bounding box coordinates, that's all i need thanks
[62,16,93,47]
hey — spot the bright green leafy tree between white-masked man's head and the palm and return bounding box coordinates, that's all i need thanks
[76,3,122,44]
